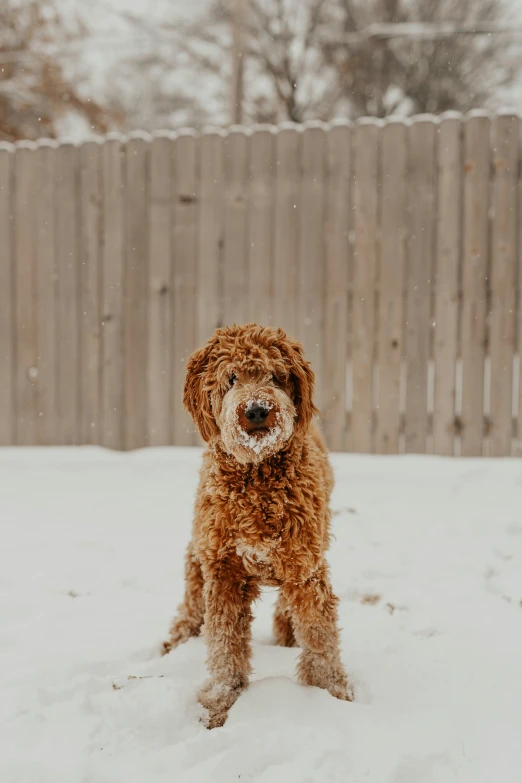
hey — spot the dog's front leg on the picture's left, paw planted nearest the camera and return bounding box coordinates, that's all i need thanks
[198,567,259,729]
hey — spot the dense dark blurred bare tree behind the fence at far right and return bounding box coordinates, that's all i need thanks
[322,0,518,116]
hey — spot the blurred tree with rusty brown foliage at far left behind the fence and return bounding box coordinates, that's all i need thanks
[0,0,116,141]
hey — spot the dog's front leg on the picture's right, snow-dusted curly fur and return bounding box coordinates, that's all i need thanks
[283,563,353,701]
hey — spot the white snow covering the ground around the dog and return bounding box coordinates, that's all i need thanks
[0,448,522,783]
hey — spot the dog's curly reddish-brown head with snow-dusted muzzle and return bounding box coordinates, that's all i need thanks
[183,324,317,464]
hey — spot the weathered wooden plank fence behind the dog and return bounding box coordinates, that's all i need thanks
[0,113,522,456]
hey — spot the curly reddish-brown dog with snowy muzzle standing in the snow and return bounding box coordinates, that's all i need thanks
[160,324,352,728]
